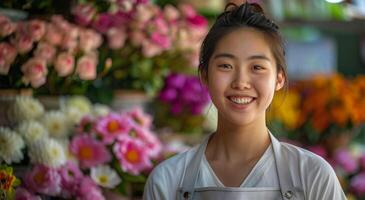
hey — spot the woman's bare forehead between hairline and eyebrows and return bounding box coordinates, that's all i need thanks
[213,28,273,60]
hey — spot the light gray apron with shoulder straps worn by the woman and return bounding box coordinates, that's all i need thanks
[177,133,304,200]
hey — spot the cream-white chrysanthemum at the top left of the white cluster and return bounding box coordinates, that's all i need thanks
[12,96,44,121]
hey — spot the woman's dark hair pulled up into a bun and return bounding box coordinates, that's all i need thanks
[198,3,287,87]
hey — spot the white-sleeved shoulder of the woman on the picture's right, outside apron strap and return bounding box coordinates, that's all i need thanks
[281,142,345,199]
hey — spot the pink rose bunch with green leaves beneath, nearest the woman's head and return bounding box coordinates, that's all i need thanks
[72,0,208,94]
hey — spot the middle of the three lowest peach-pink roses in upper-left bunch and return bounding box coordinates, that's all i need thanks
[54,52,75,77]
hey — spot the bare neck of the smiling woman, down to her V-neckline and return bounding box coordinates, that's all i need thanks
[206,115,271,163]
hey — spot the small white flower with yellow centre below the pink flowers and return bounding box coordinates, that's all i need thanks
[91,165,122,188]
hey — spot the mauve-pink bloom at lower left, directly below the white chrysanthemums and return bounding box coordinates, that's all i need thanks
[24,165,61,196]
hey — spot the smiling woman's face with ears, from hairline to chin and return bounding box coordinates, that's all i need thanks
[203,28,285,126]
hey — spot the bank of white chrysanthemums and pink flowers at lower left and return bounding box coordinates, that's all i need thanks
[0,97,162,199]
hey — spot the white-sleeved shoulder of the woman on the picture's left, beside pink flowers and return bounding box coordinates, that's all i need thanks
[144,147,197,199]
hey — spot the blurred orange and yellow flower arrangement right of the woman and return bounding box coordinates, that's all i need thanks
[271,74,365,143]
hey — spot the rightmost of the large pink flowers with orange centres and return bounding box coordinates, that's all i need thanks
[113,137,152,175]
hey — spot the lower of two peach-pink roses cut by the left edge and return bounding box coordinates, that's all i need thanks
[0,42,17,75]
